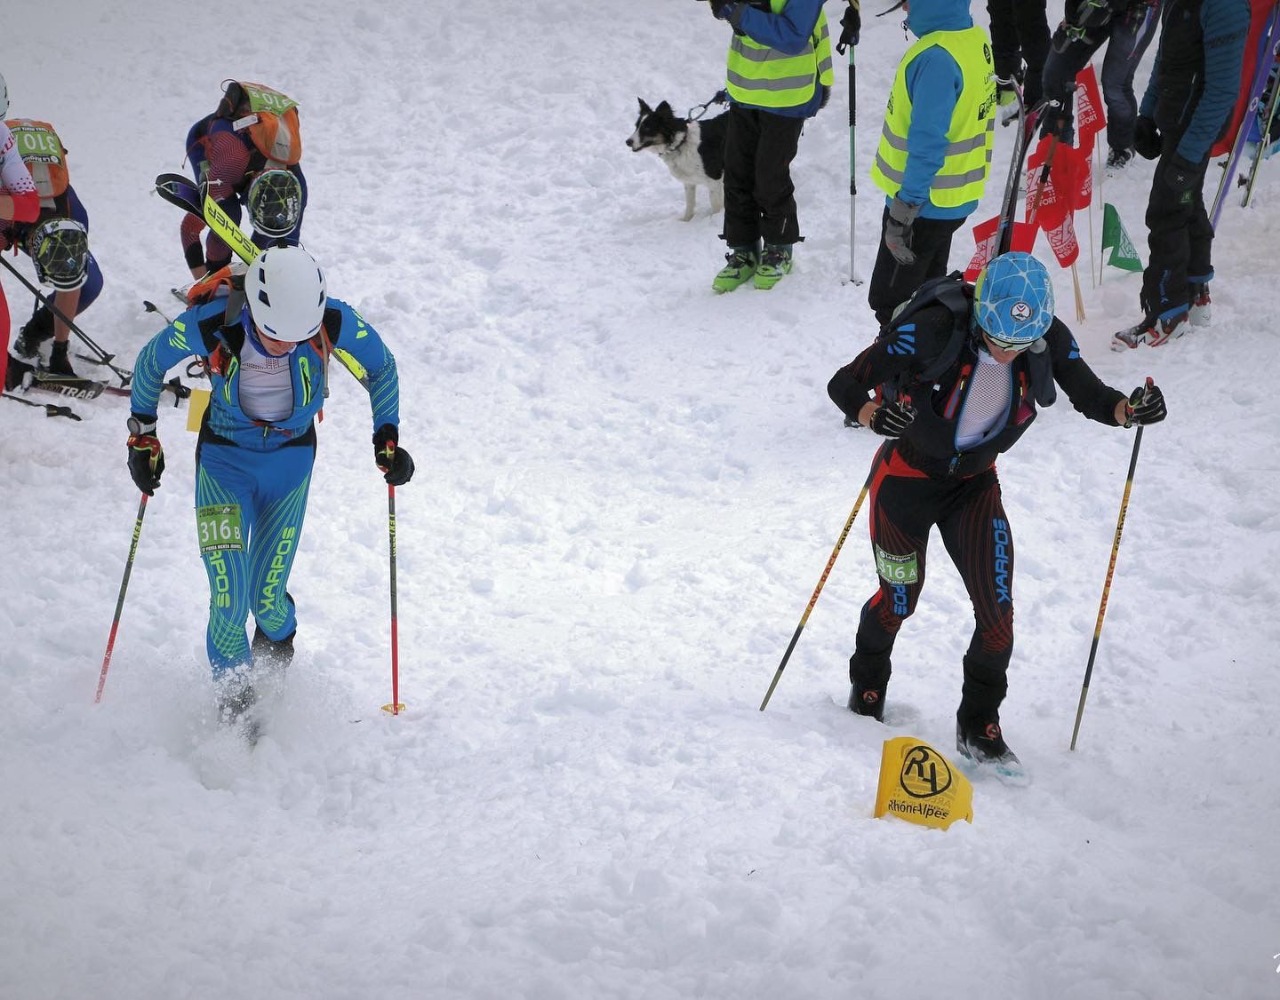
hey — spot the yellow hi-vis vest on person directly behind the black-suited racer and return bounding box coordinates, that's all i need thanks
[872,26,996,209]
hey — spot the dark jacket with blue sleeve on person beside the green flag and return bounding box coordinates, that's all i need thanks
[1139,0,1249,164]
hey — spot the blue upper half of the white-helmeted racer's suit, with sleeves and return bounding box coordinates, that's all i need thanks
[129,298,399,452]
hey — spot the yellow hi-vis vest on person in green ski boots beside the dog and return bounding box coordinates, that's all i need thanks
[727,0,836,108]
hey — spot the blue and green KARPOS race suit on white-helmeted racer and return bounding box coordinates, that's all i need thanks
[131,297,399,677]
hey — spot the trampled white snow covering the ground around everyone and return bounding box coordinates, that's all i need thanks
[0,0,1280,1000]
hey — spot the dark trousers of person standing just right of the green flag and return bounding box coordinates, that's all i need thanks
[1140,133,1213,321]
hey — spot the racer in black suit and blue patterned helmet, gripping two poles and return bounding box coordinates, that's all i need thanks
[827,252,1166,780]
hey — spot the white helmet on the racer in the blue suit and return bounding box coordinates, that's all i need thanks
[244,247,328,343]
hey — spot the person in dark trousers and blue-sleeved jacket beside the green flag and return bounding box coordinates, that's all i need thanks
[1111,0,1249,351]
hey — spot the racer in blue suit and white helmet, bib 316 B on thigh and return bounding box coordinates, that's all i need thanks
[128,246,413,721]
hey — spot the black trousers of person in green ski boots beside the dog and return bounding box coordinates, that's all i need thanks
[721,105,804,247]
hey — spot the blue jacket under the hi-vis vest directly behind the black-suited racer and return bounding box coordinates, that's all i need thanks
[886,0,978,219]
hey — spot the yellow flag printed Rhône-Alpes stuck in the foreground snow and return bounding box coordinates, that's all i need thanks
[876,736,973,830]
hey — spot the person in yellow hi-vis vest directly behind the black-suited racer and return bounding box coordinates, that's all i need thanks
[867,0,996,325]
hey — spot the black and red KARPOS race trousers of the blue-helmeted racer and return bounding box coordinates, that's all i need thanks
[849,452,1014,729]
